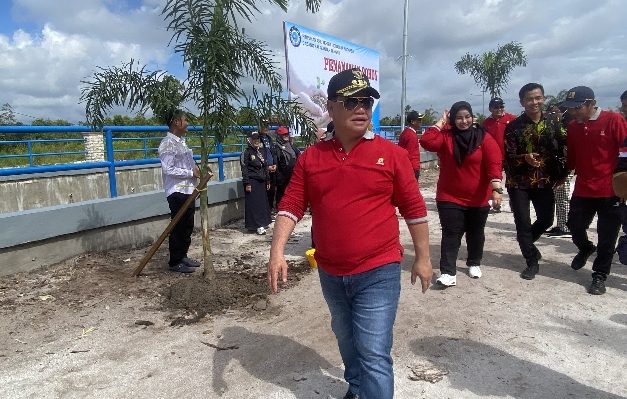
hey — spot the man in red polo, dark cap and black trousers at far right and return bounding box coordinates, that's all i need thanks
[562,86,627,295]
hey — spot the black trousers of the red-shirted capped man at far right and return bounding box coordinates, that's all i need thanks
[567,196,621,279]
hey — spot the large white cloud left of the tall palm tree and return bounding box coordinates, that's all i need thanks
[0,0,172,122]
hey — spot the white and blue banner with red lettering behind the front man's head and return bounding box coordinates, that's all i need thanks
[283,22,379,131]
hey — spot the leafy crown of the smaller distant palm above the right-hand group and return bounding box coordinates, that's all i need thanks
[455,42,527,97]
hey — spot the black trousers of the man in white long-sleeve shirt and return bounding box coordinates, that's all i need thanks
[168,193,196,266]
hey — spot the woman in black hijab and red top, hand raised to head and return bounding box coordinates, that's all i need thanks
[420,101,503,287]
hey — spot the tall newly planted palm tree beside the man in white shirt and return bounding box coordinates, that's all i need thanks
[81,0,322,279]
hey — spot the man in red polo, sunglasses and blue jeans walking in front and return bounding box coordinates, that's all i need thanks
[268,69,432,399]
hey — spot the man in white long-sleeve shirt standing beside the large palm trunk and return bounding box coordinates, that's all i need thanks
[159,109,200,273]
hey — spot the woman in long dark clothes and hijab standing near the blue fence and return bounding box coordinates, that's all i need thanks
[240,131,272,235]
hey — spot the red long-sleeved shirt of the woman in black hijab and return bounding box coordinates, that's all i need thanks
[420,126,502,207]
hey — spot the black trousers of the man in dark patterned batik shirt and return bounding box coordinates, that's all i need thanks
[507,187,555,266]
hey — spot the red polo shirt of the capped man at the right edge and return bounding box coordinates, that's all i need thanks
[567,109,627,198]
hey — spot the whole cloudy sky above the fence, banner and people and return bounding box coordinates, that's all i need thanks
[0,0,627,123]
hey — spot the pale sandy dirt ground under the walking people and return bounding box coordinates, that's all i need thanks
[0,170,627,399]
